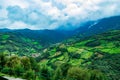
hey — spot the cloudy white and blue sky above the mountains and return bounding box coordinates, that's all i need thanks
[0,0,120,29]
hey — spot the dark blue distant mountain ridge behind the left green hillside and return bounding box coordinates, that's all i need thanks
[0,29,72,47]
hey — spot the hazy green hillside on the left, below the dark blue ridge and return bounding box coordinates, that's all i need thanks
[0,32,42,56]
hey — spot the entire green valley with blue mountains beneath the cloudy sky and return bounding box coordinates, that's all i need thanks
[0,16,120,80]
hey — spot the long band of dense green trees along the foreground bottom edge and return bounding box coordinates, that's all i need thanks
[0,53,105,80]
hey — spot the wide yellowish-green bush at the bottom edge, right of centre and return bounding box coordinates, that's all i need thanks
[67,67,106,80]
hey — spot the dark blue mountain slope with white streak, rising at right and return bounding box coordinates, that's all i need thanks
[75,16,120,37]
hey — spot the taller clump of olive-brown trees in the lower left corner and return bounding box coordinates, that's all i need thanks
[0,53,39,80]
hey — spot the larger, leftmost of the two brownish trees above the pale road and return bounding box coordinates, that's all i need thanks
[3,56,24,76]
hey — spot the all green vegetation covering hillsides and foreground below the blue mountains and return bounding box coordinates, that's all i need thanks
[0,30,120,80]
